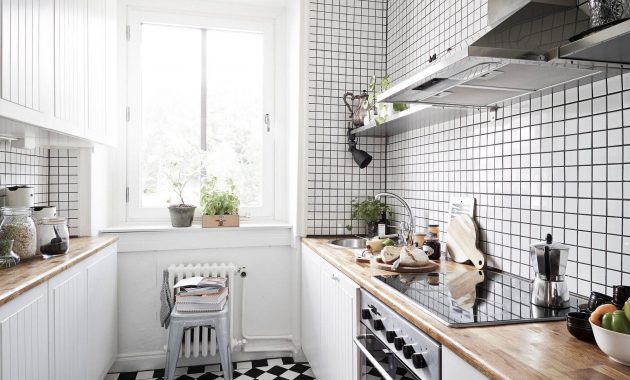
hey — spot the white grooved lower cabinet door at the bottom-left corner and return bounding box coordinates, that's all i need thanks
[0,285,49,380]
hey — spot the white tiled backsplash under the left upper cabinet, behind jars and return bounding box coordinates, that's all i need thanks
[0,142,79,235]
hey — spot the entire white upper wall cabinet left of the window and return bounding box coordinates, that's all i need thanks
[0,0,117,145]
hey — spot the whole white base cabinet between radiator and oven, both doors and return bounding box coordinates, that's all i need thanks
[302,245,359,380]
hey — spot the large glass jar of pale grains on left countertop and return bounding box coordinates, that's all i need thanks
[0,207,37,260]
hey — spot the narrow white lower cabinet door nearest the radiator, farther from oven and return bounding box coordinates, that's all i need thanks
[301,245,323,378]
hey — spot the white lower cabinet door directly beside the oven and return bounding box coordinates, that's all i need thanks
[321,264,358,379]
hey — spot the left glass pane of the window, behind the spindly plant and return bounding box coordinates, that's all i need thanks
[140,24,202,207]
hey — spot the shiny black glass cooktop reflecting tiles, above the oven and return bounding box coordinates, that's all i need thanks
[375,270,588,327]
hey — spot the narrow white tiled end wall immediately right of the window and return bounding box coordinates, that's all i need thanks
[307,0,387,235]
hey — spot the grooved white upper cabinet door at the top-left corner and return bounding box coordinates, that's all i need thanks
[0,0,53,126]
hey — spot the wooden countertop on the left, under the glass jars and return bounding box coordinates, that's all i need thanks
[0,236,118,305]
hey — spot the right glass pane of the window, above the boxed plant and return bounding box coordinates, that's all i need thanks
[206,30,264,207]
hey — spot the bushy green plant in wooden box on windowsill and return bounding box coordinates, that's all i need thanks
[201,177,241,228]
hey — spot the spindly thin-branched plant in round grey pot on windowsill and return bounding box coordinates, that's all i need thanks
[164,161,199,227]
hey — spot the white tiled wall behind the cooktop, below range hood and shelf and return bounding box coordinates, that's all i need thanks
[387,74,630,295]
